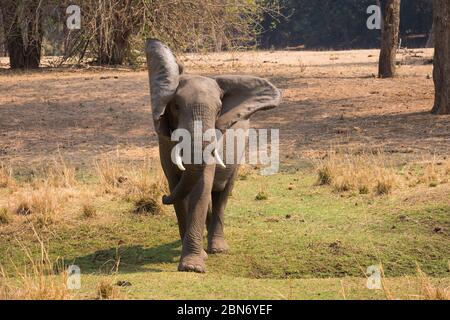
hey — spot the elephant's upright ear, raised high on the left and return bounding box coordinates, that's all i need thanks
[145,39,183,134]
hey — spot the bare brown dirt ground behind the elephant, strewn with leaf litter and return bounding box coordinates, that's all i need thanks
[0,49,450,166]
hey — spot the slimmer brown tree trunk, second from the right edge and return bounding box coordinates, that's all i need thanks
[378,0,400,78]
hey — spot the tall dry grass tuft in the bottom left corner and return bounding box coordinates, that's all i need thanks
[0,228,70,300]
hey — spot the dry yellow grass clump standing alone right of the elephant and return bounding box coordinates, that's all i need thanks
[316,152,397,195]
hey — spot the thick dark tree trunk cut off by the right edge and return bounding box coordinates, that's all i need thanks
[432,0,450,114]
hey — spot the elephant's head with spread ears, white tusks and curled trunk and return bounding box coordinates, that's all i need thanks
[146,39,281,203]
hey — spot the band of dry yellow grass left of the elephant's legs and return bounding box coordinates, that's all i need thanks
[0,157,168,226]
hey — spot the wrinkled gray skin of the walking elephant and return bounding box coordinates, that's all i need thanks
[146,39,281,272]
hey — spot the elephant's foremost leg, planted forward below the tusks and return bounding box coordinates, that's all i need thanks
[178,165,215,272]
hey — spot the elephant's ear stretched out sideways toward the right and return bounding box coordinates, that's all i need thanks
[214,75,281,130]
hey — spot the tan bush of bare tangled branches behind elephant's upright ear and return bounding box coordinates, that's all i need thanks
[76,0,273,64]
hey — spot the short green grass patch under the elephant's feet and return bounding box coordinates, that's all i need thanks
[0,169,450,299]
